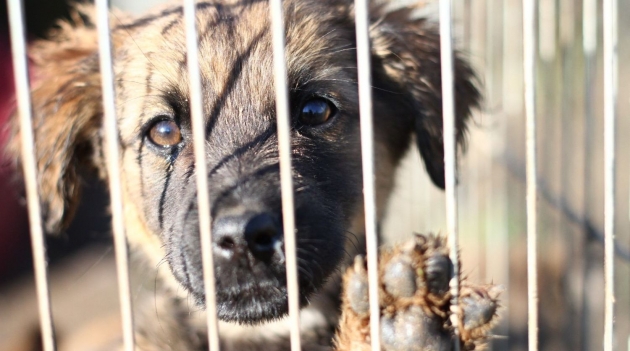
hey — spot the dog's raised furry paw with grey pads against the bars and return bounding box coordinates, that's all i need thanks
[335,235,500,351]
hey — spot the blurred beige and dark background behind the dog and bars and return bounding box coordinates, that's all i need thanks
[0,0,630,351]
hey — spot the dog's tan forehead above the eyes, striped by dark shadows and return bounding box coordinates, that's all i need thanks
[116,0,354,140]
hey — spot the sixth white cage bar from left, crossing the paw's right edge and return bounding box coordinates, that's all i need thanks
[440,0,461,351]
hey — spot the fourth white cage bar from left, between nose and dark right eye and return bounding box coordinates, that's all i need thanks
[269,0,301,351]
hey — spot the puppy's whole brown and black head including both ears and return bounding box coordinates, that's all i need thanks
[8,0,478,323]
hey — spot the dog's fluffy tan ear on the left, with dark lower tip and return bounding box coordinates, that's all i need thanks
[8,14,102,232]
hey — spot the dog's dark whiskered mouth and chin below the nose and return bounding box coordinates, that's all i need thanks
[193,284,312,325]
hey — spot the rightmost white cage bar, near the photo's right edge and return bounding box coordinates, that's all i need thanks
[603,0,618,351]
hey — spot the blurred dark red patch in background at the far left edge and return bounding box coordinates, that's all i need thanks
[0,30,30,280]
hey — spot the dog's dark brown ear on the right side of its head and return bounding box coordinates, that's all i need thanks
[370,8,480,188]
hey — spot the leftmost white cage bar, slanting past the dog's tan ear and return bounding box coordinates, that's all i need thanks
[6,0,56,351]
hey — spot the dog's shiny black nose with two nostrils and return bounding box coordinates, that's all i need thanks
[212,213,282,259]
